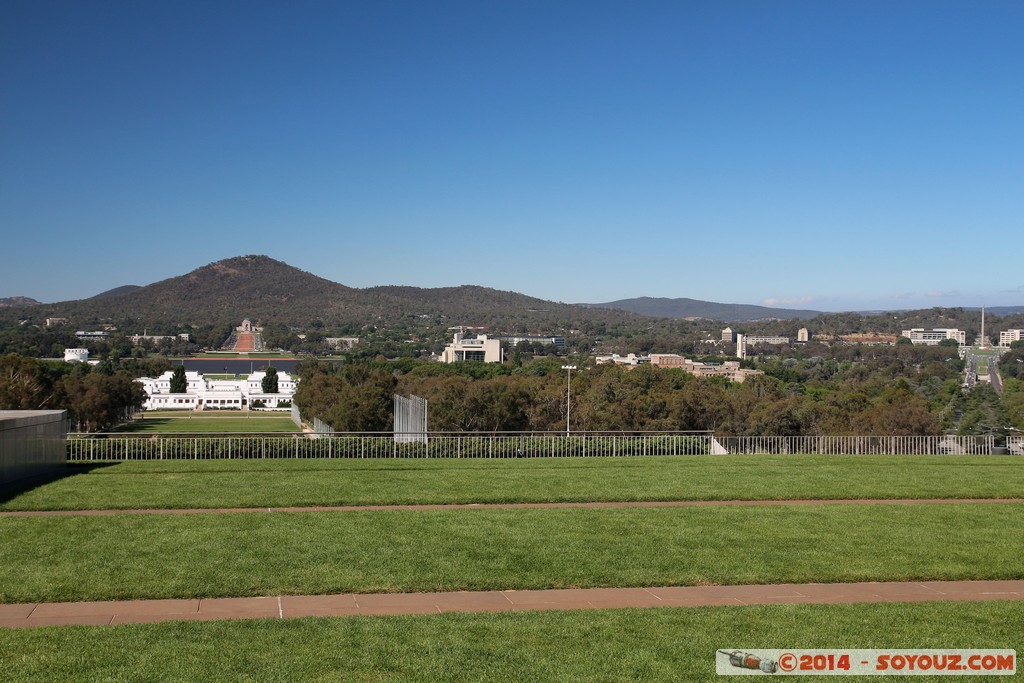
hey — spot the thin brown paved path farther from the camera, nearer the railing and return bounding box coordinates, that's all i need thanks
[0,498,1024,517]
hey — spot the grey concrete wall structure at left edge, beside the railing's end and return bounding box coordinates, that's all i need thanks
[0,411,68,486]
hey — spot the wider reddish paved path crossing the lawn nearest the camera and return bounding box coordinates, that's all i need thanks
[0,581,1024,628]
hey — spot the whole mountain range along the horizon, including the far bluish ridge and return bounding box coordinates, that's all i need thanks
[0,255,1024,336]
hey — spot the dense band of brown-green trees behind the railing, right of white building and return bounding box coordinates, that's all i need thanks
[296,346,964,436]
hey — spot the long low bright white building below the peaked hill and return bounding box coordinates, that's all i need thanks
[135,370,298,411]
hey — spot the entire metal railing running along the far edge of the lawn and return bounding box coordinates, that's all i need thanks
[68,432,1007,461]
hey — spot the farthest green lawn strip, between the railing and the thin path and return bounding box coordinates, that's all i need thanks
[0,456,1024,510]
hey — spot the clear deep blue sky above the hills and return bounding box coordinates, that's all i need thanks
[0,0,1024,310]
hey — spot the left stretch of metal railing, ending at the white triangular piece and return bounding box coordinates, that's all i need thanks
[68,432,713,461]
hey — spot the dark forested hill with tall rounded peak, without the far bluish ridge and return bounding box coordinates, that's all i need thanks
[0,256,636,329]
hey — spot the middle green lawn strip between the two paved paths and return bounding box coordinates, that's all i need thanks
[0,504,1024,602]
